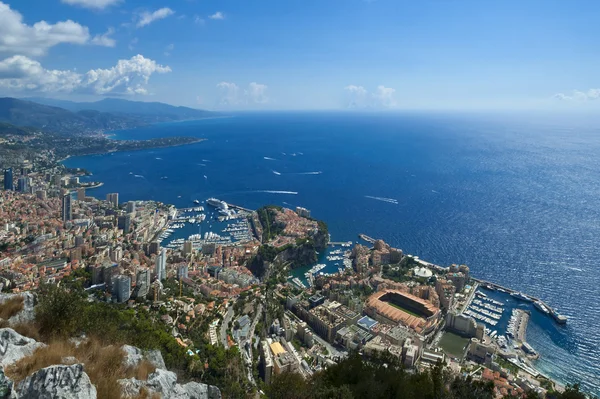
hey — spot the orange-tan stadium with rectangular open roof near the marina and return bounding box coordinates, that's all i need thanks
[365,290,441,335]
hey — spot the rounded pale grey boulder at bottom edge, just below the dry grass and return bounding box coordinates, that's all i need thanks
[13,364,97,399]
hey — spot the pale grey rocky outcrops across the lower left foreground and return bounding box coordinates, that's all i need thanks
[0,293,221,399]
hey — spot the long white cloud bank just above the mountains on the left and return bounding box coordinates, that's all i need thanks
[0,54,171,95]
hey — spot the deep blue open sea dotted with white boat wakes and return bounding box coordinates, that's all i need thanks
[65,112,600,394]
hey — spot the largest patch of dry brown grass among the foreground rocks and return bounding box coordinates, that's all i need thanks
[5,339,156,399]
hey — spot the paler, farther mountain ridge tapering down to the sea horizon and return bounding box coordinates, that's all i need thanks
[28,97,215,123]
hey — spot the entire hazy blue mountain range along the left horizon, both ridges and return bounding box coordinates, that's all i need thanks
[0,97,216,135]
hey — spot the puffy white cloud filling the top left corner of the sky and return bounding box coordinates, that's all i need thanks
[0,1,110,56]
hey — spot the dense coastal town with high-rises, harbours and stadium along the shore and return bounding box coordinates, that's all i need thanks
[0,155,567,398]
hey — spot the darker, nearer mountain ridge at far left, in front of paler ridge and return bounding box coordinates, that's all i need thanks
[0,97,145,134]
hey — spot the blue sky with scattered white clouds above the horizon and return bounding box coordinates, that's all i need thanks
[0,0,600,110]
